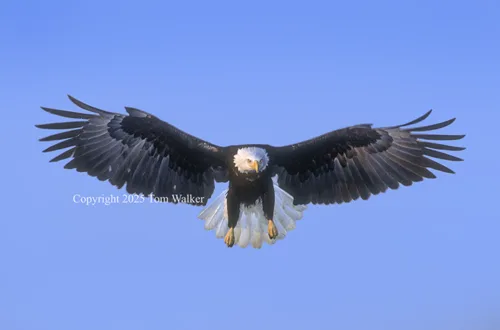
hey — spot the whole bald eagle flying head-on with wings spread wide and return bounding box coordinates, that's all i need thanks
[36,96,465,248]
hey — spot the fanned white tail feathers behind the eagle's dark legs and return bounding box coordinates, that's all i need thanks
[198,181,307,248]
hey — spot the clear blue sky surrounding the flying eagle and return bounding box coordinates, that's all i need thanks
[0,0,500,330]
